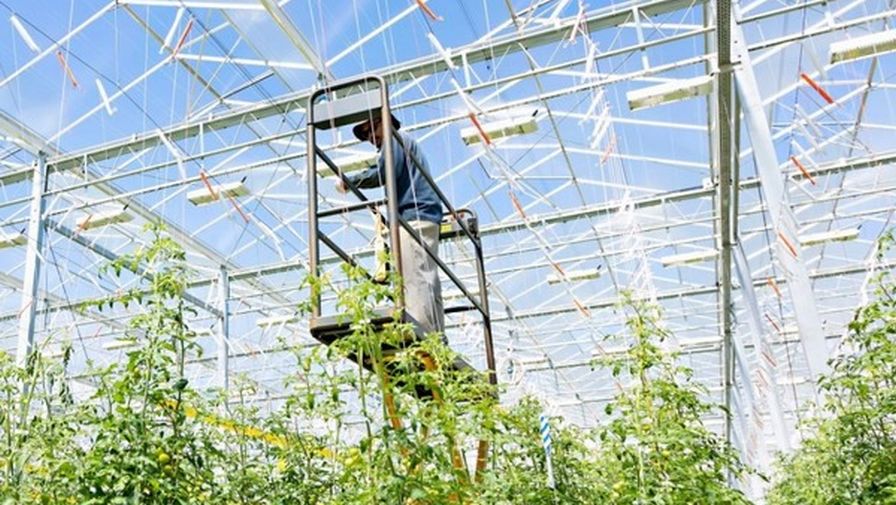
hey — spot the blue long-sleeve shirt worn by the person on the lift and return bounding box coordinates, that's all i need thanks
[348,132,442,224]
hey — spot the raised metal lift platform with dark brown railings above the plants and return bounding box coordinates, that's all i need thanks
[307,76,497,398]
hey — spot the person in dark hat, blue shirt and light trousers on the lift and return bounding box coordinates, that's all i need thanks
[336,116,445,334]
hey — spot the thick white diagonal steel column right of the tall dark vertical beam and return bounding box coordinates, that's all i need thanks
[731,3,828,381]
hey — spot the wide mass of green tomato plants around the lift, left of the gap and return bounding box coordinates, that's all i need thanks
[0,227,745,505]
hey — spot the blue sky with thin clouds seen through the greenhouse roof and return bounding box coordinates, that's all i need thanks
[0,0,893,434]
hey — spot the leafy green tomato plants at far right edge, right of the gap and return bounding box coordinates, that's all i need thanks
[768,233,896,505]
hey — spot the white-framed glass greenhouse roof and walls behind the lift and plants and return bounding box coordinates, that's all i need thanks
[0,0,896,472]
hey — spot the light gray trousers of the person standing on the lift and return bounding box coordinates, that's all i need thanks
[399,221,445,334]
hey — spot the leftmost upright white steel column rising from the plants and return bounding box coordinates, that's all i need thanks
[16,152,47,366]
